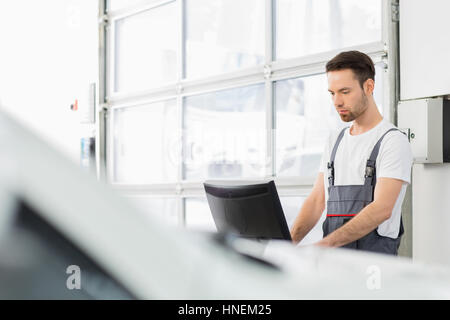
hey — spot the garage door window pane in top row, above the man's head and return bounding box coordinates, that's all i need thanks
[276,0,382,59]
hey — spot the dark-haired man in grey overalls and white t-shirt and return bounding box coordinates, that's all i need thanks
[291,51,413,255]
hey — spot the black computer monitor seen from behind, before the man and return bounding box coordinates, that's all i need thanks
[204,181,291,240]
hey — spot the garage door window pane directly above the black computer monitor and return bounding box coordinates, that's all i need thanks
[183,85,266,181]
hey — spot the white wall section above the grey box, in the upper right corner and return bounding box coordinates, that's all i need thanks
[400,0,450,100]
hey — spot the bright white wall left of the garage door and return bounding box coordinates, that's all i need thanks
[0,0,98,162]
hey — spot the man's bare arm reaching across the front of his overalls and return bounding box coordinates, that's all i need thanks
[316,178,403,247]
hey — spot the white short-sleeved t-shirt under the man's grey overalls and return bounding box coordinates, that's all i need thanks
[319,119,413,239]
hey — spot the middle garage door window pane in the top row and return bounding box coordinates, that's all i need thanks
[185,0,265,78]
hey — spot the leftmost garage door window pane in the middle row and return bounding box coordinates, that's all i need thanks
[113,100,180,183]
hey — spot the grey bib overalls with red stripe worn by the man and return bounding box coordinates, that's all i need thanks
[322,128,403,255]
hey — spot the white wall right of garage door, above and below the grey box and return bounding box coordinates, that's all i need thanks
[399,0,450,265]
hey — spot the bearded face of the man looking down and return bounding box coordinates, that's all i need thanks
[327,69,371,122]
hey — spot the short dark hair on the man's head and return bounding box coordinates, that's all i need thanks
[326,50,375,88]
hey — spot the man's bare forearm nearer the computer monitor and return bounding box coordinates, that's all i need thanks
[291,172,325,243]
